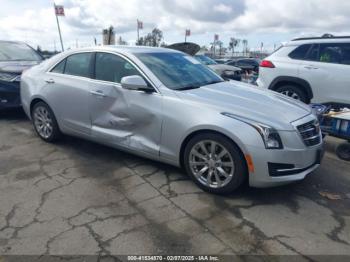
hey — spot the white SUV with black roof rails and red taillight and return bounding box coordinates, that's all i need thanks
[257,36,350,106]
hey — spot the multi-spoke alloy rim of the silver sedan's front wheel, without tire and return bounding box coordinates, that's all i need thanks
[189,140,235,188]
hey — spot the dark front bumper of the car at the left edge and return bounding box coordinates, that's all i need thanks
[0,81,21,109]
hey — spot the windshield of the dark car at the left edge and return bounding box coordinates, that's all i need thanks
[0,42,42,61]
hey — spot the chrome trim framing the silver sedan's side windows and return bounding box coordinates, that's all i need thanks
[46,50,161,94]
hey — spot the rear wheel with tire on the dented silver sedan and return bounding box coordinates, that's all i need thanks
[31,102,61,143]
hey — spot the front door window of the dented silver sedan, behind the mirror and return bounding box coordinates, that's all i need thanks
[95,53,140,83]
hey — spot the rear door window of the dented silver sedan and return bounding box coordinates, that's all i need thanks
[64,53,93,77]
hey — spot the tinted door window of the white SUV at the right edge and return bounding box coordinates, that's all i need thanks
[319,43,350,65]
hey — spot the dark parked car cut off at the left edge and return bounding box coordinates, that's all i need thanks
[0,40,43,110]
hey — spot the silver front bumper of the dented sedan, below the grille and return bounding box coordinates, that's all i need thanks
[248,140,323,187]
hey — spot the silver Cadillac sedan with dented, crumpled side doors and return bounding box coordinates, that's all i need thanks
[21,46,322,193]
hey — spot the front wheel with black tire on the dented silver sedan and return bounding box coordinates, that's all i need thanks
[183,132,248,194]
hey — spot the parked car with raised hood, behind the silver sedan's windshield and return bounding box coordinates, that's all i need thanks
[167,42,242,81]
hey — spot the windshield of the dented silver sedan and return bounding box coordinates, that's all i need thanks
[135,52,223,90]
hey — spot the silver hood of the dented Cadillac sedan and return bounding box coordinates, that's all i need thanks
[178,81,311,131]
